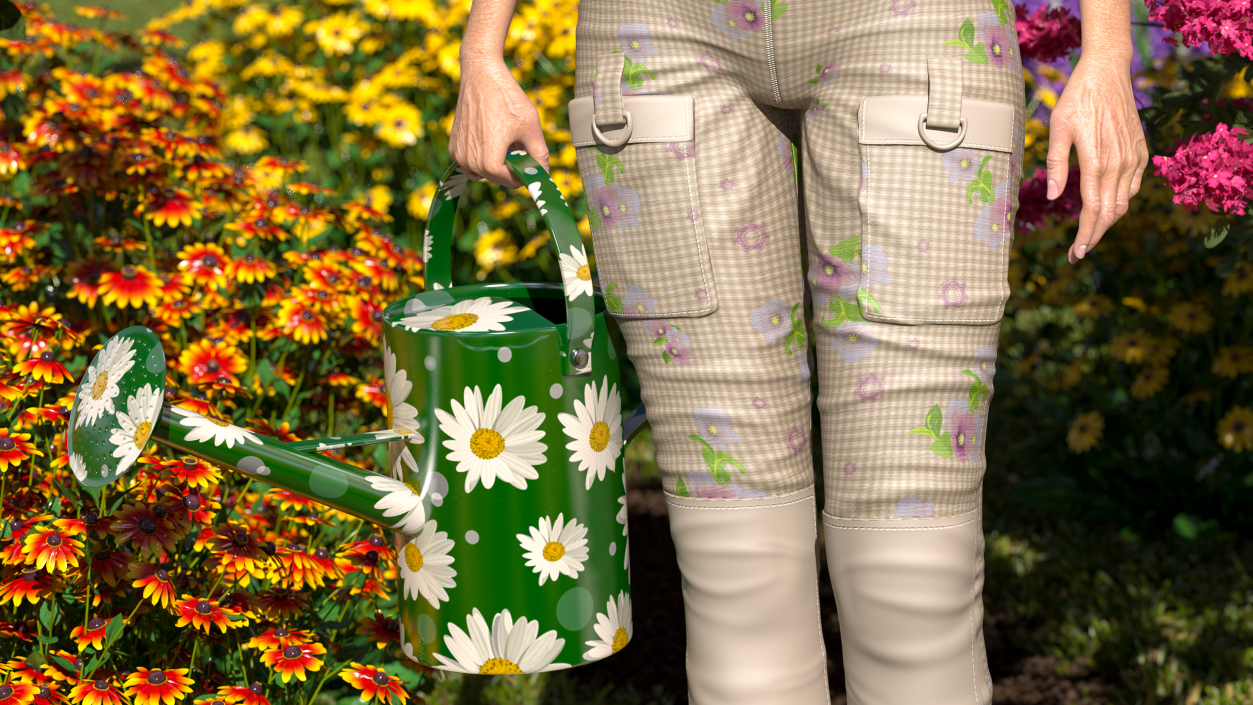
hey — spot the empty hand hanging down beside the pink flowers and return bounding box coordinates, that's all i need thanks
[1048,58,1149,264]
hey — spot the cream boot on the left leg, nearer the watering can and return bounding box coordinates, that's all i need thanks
[665,487,831,705]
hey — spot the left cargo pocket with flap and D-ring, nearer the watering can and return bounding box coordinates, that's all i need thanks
[570,53,718,318]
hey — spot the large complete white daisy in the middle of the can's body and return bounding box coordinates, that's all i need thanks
[435,384,548,492]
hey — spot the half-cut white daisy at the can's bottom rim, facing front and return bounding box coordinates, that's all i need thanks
[435,607,570,675]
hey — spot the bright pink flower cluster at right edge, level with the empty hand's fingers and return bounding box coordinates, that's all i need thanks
[1153,122,1253,215]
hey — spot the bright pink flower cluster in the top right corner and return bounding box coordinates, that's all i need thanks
[1149,0,1253,58]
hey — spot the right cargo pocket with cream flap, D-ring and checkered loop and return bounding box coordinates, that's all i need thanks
[852,59,1017,324]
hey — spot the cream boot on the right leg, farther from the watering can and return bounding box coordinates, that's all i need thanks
[822,511,992,705]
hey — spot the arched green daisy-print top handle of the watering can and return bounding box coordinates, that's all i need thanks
[422,152,595,377]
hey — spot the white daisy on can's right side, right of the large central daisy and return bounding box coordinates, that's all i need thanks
[556,376,623,490]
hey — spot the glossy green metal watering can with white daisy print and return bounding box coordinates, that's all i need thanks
[68,153,644,674]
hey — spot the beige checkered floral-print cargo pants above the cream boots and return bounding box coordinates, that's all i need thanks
[575,0,1025,518]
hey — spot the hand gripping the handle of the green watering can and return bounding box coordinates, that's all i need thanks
[449,55,549,188]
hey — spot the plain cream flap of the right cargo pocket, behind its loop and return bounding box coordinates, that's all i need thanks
[857,95,1014,152]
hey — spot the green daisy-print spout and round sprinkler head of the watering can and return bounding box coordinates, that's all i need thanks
[66,326,432,536]
